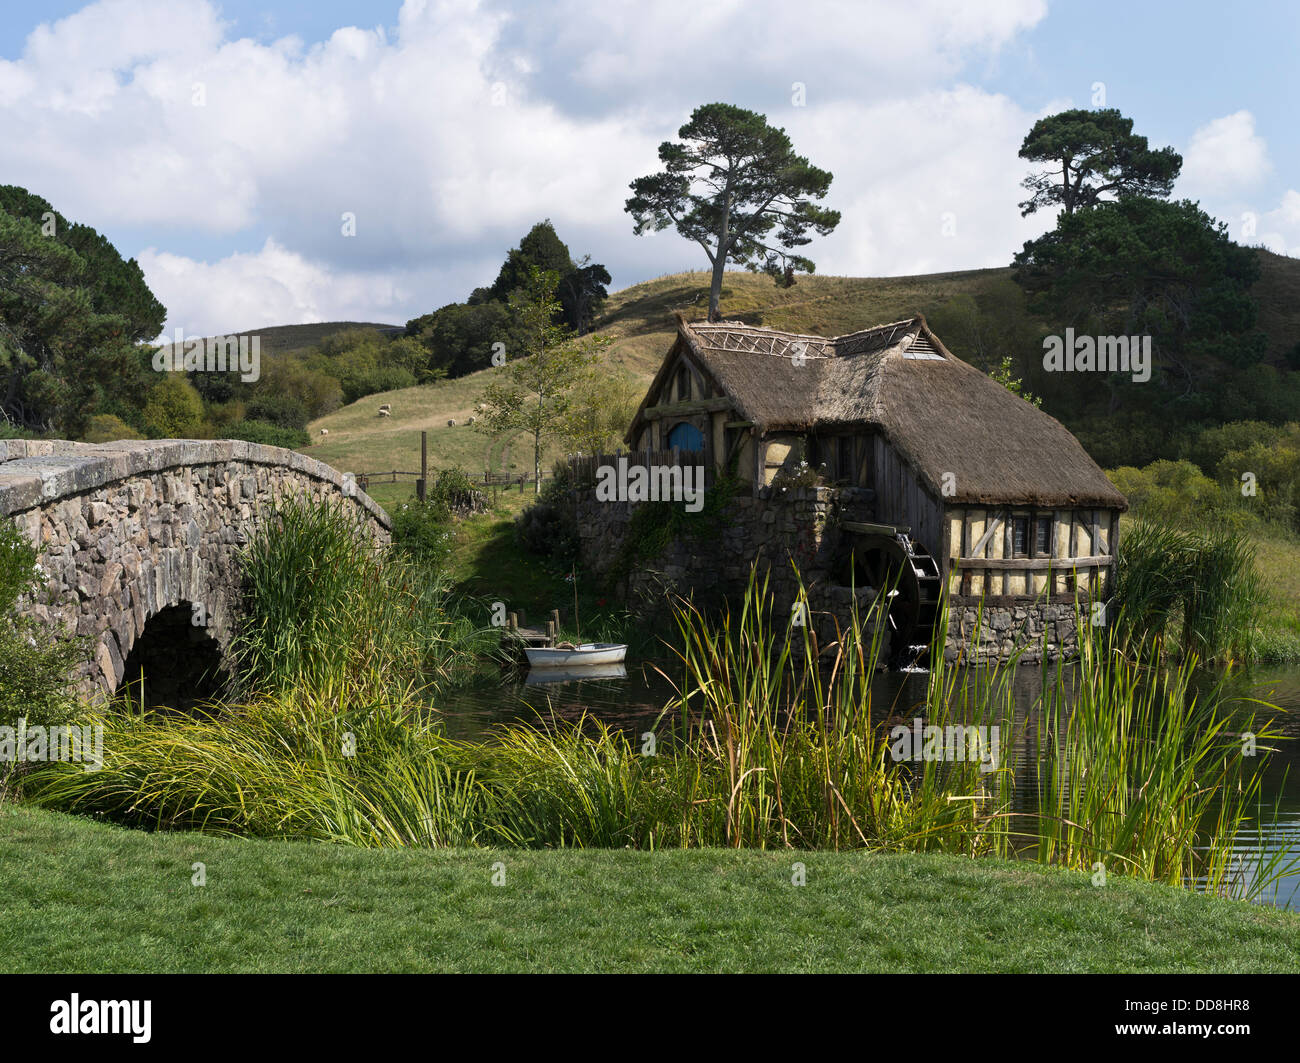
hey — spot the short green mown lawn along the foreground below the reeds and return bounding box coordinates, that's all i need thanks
[0,806,1300,973]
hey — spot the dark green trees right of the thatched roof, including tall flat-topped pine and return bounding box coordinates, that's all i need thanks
[1014,109,1300,464]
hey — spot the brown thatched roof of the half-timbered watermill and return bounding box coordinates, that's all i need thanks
[628,314,1127,509]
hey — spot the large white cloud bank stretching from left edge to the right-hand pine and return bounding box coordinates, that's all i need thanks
[0,0,1044,331]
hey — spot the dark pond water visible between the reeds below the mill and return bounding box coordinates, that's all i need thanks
[439,661,1300,910]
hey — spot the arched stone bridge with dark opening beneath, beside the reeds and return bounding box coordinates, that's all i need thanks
[0,439,390,704]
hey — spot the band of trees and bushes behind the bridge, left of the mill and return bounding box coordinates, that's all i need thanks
[0,186,615,446]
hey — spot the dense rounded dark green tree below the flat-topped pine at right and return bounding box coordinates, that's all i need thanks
[1015,198,1265,447]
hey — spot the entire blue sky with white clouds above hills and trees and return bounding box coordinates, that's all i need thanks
[0,0,1300,334]
